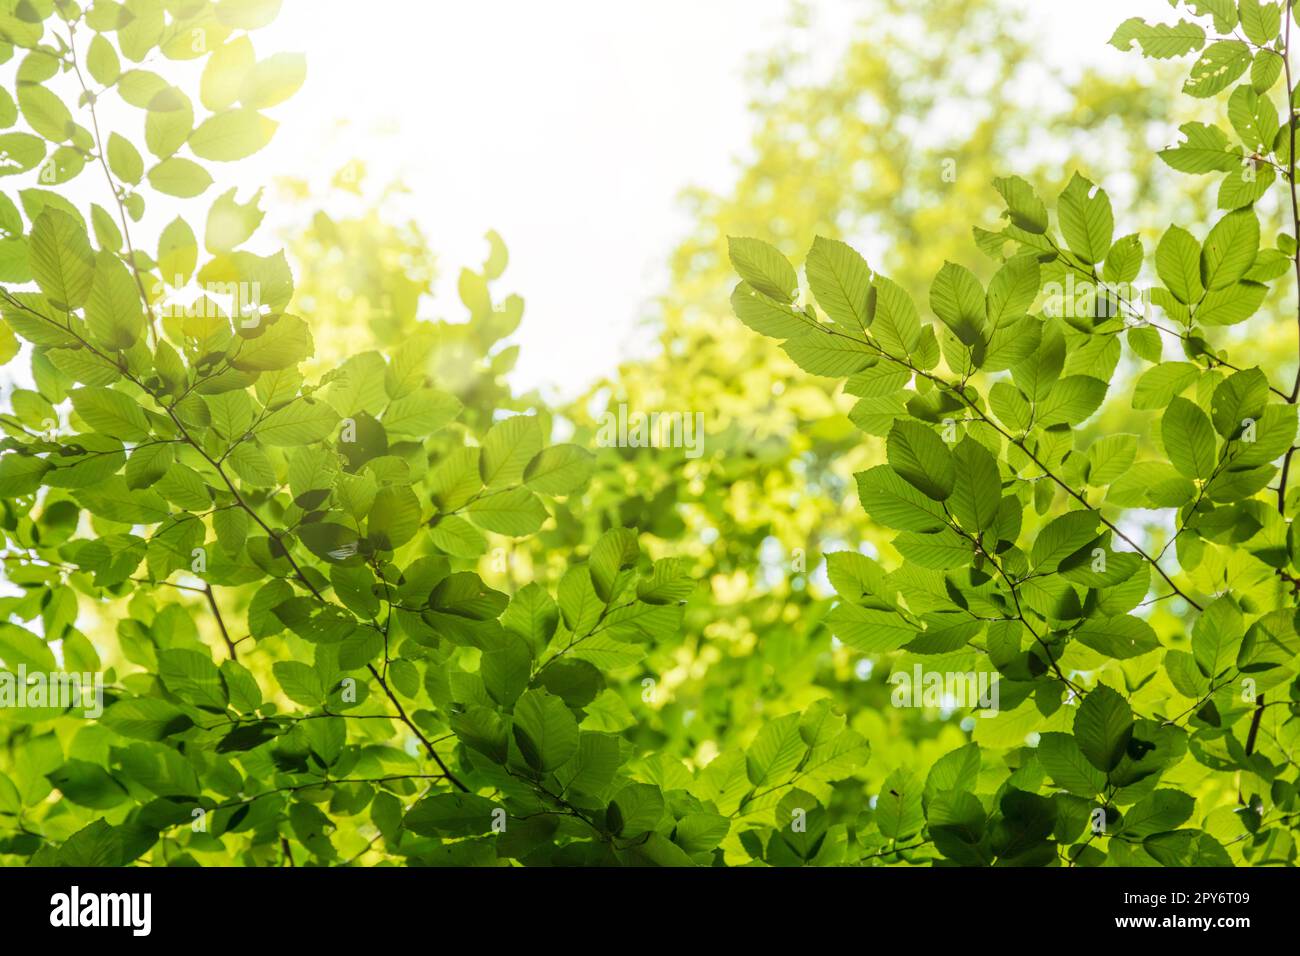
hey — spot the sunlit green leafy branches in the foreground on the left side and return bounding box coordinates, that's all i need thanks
[0,0,867,865]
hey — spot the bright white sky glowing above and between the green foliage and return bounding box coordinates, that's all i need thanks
[7,0,1177,397]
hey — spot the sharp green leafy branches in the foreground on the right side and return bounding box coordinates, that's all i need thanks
[731,1,1300,865]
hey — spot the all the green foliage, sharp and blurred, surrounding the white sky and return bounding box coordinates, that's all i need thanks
[0,0,1300,866]
